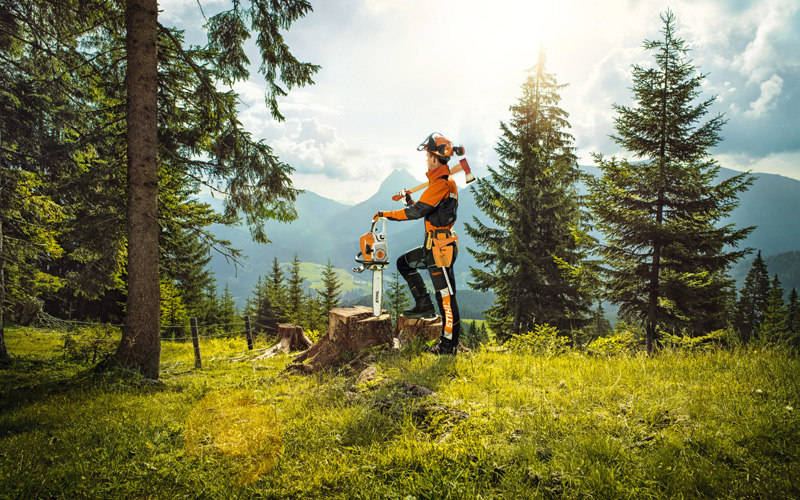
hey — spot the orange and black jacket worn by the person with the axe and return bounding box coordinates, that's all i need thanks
[383,165,458,234]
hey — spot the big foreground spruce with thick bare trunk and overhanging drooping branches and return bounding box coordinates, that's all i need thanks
[0,0,319,377]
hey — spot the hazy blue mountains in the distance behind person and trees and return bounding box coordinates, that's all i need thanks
[202,167,800,307]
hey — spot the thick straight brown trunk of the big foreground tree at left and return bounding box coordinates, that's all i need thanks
[116,0,161,379]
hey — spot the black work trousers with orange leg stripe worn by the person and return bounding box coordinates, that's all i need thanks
[397,247,461,342]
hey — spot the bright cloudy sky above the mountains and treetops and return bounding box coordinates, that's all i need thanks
[159,0,800,203]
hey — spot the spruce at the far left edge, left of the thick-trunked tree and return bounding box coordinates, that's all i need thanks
[0,0,95,359]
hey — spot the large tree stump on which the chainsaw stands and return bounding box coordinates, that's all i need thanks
[285,306,392,374]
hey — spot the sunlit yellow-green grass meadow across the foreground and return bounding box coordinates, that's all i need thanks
[0,328,800,500]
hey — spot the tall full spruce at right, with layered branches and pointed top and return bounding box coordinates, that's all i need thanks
[589,10,753,352]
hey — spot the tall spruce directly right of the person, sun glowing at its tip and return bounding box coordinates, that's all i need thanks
[465,49,588,338]
